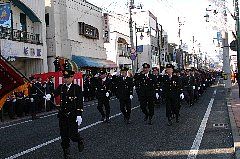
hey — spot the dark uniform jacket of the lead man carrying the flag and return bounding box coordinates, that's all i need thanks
[54,84,83,116]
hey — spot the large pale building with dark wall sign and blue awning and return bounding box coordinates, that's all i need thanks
[46,0,115,74]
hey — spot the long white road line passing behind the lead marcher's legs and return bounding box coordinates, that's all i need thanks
[5,106,140,159]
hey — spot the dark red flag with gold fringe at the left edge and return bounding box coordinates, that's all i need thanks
[0,58,28,110]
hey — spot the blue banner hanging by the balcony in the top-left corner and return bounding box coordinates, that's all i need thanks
[0,4,12,28]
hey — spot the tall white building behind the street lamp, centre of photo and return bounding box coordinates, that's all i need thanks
[133,9,161,68]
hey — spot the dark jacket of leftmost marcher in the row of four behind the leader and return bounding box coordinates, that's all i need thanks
[96,78,112,100]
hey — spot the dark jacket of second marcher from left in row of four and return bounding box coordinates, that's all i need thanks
[116,76,134,99]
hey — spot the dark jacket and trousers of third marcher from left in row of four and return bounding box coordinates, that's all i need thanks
[139,74,157,118]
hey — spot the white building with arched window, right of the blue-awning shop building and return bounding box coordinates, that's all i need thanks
[104,14,132,69]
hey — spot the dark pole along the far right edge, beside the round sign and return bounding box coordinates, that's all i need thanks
[235,0,240,98]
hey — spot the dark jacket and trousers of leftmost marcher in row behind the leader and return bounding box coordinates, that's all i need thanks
[96,78,112,119]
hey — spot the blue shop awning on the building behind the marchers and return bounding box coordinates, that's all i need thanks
[72,55,117,68]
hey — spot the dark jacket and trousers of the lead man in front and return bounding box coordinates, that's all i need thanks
[54,84,83,150]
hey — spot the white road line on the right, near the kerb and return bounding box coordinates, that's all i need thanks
[187,90,217,159]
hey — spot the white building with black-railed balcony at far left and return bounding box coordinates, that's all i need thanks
[0,0,48,76]
